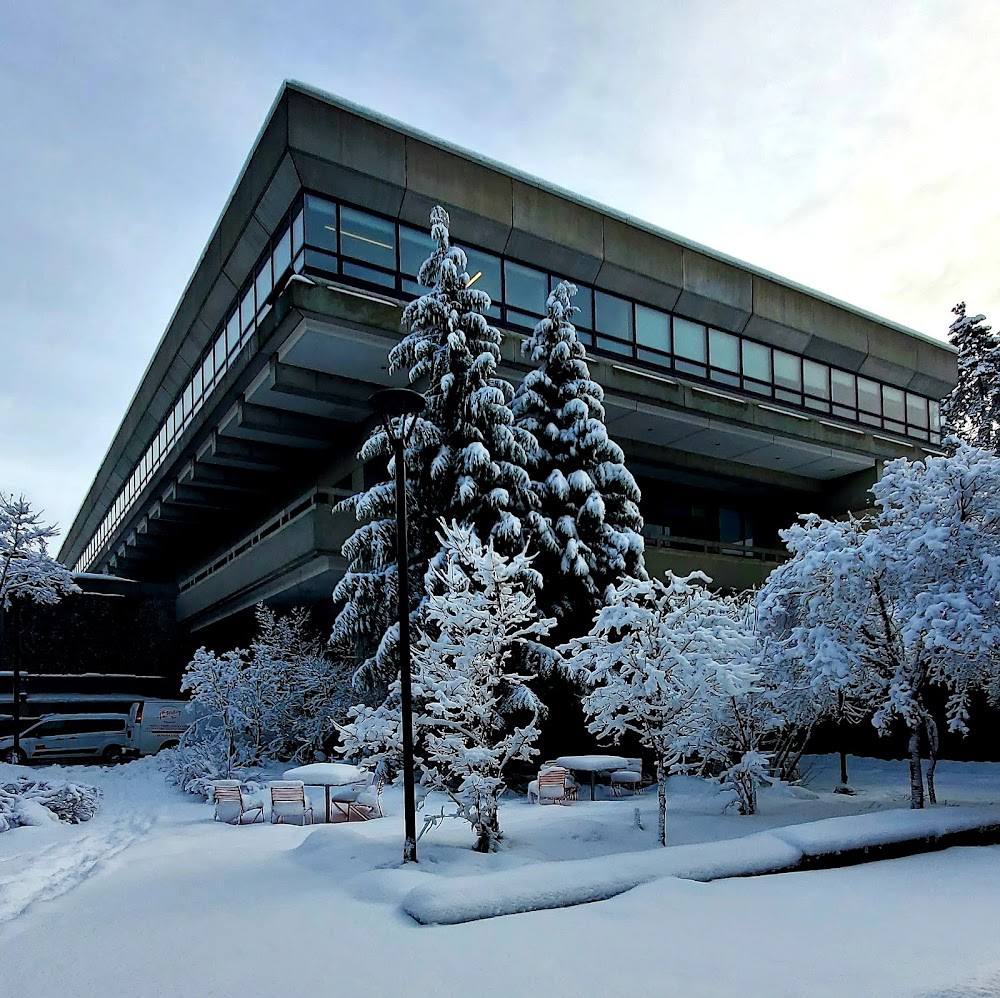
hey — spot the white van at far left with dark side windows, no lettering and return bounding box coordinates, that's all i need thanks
[0,714,132,765]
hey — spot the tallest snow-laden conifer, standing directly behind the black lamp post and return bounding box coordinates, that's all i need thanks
[333,206,537,685]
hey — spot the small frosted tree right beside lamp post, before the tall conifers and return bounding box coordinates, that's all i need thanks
[343,523,554,852]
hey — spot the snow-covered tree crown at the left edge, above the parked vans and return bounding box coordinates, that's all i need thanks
[0,492,79,612]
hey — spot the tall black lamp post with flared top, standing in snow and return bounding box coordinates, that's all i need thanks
[368,388,424,863]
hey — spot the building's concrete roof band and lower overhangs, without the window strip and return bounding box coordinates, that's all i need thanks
[60,83,955,628]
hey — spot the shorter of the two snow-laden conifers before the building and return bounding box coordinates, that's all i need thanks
[513,281,646,637]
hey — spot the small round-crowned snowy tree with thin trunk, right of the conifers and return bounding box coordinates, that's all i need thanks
[563,572,756,845]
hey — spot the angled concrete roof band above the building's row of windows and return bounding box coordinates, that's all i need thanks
[60,82,956,563]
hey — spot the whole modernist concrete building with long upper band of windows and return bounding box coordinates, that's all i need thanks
[60,83,956,631]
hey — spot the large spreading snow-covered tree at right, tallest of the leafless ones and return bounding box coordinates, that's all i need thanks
[762,440,1000,808]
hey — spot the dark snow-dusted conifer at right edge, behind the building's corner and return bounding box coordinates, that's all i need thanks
[941,301,1000,454]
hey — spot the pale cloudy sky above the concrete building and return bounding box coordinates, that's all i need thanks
[0,0,1000,529]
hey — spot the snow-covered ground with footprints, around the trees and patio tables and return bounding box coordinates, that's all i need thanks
[0,758,1000,998]
